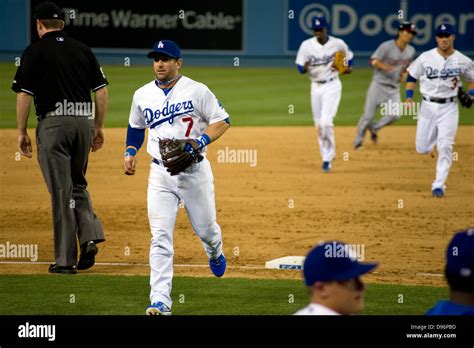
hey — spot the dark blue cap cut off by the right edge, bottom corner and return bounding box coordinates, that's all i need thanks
[445,228,474,281]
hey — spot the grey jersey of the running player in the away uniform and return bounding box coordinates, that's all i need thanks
[370,40,415,87]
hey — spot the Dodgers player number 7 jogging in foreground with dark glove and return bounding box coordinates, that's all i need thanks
[124,40,230,315]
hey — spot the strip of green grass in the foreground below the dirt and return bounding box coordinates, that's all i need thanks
[0,274,448,315]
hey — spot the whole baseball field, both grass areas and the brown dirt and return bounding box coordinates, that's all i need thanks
[0,63,474,315]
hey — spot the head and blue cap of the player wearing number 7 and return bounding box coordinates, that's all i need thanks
[147,40,183,82]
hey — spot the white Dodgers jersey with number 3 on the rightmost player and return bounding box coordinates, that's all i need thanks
[408,48,474,98]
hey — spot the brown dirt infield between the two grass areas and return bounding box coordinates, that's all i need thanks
[0,126,474,285]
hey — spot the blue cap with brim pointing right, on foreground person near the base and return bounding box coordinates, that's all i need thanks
[303,241,378,286]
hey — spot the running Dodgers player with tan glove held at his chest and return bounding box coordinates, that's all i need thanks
[296,16,354,172]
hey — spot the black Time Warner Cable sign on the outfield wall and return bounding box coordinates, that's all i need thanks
[30,0,244,51]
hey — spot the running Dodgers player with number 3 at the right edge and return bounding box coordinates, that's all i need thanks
[405,24,474,197]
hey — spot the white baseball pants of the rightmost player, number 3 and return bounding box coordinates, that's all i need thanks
[416,100,459,190]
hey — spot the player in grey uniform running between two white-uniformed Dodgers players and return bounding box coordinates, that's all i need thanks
[354,22,416,150]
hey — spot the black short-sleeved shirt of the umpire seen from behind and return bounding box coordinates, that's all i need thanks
[12,31,108,116]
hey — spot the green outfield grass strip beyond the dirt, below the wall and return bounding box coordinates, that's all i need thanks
[0,63,474,128]
